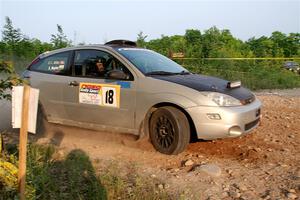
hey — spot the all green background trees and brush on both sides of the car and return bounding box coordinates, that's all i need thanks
[0,17,300,91]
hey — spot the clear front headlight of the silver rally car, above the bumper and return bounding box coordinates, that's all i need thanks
[202,92,242,106]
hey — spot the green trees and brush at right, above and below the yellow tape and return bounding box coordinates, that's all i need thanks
[140,26,300,89]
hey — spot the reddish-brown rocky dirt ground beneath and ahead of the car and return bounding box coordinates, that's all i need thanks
[1,89,300,199]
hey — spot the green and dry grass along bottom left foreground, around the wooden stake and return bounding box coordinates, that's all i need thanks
[0,144,171,200]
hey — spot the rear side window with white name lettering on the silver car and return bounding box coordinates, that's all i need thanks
[30,51,71,75]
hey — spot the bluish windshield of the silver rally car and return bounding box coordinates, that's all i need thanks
[118,48,188,75]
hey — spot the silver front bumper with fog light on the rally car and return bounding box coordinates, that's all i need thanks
[186,99,262,140]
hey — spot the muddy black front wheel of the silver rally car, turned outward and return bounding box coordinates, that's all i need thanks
[149,107,190,155]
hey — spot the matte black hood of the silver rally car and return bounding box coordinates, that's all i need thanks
[152,74,255,103]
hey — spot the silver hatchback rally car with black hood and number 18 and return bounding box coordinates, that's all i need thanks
[23,40,261,154]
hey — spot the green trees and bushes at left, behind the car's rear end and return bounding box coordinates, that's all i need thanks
[0,17,70,100]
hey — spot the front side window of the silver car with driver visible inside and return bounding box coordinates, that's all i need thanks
[72,50,132,79]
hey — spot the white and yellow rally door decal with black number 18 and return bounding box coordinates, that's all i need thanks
[79,83,120,108]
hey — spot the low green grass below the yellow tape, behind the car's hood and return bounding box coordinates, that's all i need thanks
[177,60,300,90]
